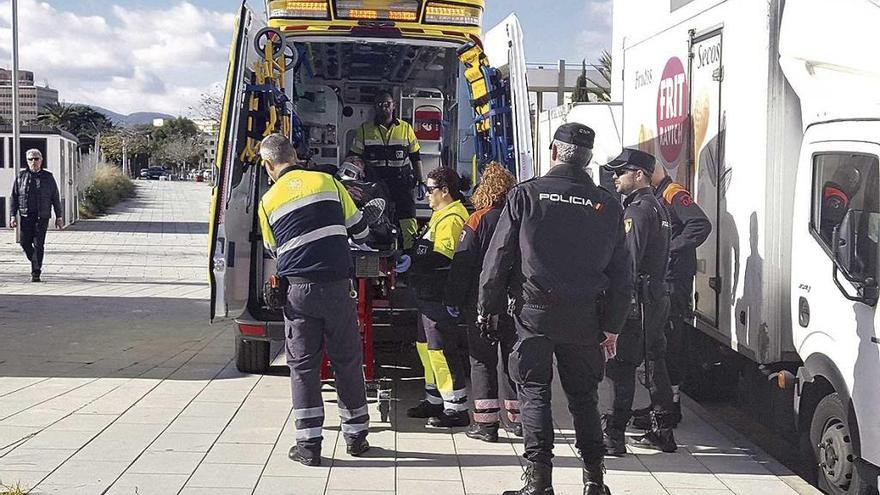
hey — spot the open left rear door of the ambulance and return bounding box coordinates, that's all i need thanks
[208,2,266,321]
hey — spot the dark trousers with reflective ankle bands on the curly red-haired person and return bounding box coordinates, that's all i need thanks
[465,308,520,424]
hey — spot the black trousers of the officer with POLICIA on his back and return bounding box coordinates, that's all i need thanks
[509,328,605,464]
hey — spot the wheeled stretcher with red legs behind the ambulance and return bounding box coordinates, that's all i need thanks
[321,248,397,422]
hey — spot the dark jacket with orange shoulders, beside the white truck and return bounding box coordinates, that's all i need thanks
[654,177,712,282]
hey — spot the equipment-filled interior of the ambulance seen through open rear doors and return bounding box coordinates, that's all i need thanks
[254,39,470,309]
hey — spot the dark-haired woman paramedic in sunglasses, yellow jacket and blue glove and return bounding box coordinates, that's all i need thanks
[406,167,470,427]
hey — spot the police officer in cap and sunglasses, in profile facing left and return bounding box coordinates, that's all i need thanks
[603,148,677,455]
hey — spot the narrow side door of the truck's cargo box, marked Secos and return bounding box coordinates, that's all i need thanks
[689,29,724,327]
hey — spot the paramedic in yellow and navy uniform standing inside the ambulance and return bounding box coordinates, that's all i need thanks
[351,91,422,249]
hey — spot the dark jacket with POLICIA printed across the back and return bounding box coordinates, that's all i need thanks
[478,164,632,344]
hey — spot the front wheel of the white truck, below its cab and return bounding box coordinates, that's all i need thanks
[810,392,875,495]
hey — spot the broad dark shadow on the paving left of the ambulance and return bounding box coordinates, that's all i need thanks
[0,295,235,380]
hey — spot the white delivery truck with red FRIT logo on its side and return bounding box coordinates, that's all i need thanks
[600,0,880,494]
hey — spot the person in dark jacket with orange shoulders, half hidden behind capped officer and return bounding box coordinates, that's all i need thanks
[633,162,712,429]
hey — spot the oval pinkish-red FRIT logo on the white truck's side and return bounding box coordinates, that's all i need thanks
[657,57,688,168]
